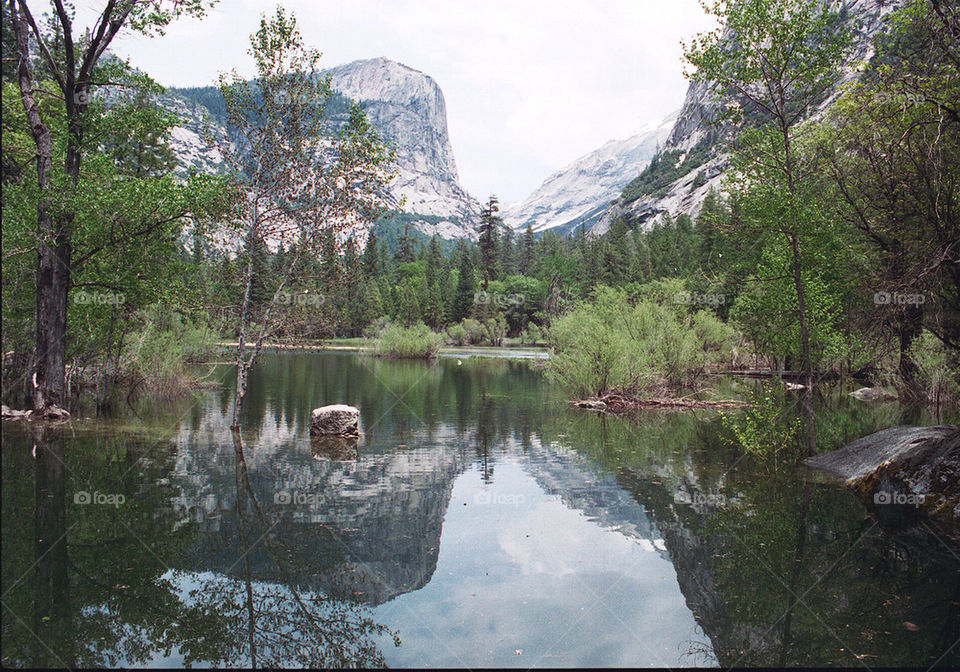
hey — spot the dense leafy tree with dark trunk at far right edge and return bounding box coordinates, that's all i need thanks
[817,2,960,394]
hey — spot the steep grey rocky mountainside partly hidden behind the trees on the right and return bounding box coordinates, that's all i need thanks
[590,0,903,234]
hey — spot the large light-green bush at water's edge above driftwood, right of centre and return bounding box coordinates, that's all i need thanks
[548,286,735,396]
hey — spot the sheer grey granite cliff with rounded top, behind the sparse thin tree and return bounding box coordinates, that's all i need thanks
[167,58,480,239]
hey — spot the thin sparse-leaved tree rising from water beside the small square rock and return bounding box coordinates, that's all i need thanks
[219,8,392,428]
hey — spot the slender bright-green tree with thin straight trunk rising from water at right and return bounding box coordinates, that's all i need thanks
[684,0,850,451]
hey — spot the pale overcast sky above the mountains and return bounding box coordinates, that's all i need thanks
[76,0,710,202]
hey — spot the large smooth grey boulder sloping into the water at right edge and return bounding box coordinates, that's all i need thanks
[806,425,960,533]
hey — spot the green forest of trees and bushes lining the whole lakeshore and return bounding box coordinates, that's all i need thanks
[2,0,960,404]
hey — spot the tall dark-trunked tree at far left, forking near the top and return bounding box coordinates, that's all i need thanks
[4,0,216,410]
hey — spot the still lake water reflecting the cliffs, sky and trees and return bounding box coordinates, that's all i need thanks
[2,353,960,668]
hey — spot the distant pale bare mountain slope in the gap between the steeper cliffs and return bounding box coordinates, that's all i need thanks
[501,113,677,239]
